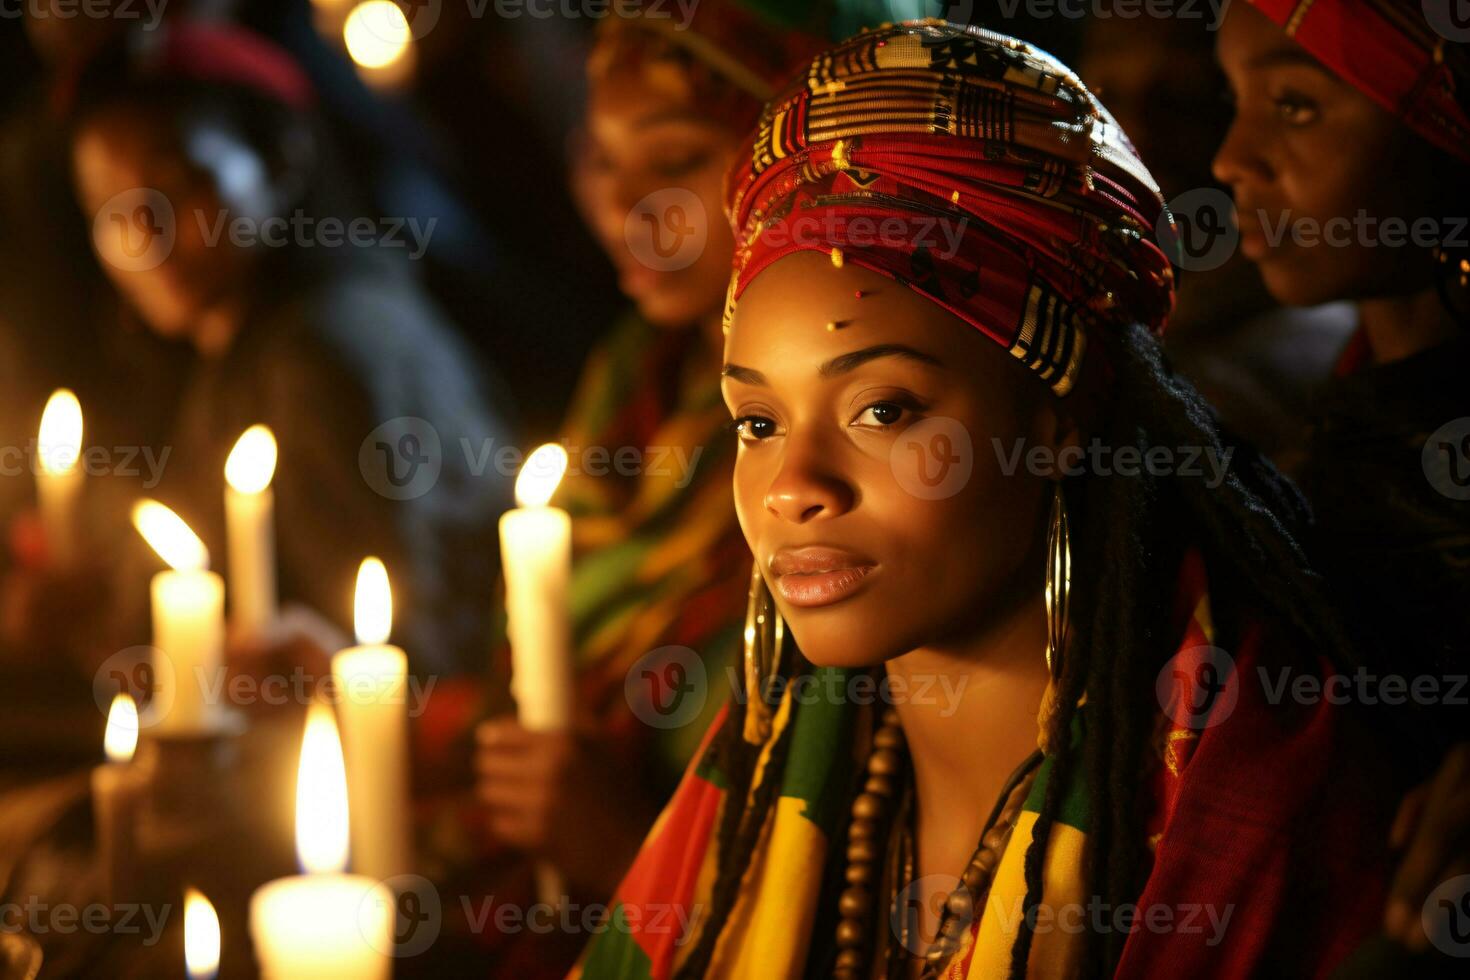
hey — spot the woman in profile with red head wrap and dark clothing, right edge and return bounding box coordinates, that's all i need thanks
[1214,0,1470,976]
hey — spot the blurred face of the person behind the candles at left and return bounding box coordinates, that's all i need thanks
[72,109,265,338]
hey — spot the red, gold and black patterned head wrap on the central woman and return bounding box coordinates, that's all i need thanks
[726,21,1173,395]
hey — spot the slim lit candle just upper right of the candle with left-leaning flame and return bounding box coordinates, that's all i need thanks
[225,425,276,633]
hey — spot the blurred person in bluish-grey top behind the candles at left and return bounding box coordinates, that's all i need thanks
[6,22,509,690]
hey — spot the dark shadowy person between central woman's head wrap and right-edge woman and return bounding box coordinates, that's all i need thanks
[1078,4,1352,472]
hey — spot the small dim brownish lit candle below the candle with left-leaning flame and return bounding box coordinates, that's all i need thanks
[91,693,143,904]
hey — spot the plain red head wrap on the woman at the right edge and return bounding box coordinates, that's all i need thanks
[1247,0,1470,163]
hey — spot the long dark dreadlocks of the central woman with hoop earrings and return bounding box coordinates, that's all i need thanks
[678,318,1360,979]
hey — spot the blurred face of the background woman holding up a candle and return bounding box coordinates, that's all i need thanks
[575,65,742,328]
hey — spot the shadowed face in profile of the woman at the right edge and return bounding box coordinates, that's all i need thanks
[1214,4,1446,306]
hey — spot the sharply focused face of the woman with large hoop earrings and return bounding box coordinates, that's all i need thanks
[723,251,1058,666]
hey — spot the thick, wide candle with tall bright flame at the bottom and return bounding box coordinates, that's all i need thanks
[250,704,394,980]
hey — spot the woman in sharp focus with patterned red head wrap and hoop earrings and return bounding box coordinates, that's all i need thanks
[567,21,1405,979]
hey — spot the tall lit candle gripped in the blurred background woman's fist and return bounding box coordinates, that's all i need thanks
[500,444,573,905]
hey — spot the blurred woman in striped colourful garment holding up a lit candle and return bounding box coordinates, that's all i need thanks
[438,0,823,973]
